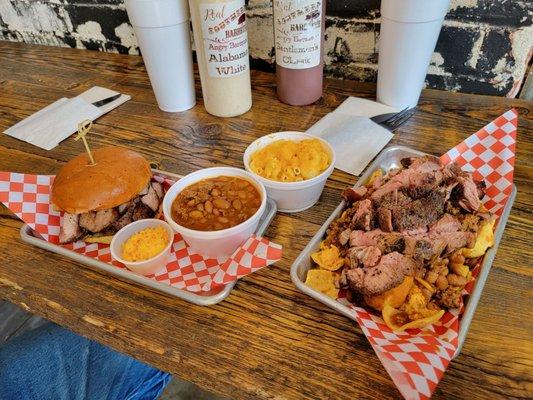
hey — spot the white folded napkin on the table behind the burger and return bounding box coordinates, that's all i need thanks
[4,86,131,150]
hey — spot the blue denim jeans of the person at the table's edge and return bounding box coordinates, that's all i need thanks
[0,323,171,400]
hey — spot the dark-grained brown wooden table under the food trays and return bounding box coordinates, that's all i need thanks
[0,42,533,399]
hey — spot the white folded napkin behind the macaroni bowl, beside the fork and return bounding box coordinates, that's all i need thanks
[307,97,396,175]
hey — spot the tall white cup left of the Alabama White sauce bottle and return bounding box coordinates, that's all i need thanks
[125,0,196,112]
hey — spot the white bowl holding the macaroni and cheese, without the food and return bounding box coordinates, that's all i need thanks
[243,131,335,213]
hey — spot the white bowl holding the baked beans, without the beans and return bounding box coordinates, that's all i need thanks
[163,167,267,257]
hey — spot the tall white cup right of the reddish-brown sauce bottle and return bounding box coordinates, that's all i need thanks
[376,0,450,109]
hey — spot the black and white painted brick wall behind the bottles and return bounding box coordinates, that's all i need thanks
[0,0,533,97]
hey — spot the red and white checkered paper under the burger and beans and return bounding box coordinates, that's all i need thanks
[0,172,281,293]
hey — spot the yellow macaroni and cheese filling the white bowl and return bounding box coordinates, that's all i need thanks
[250,139,331,182]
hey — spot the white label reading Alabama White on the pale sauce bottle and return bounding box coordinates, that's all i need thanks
[200,0,250,78]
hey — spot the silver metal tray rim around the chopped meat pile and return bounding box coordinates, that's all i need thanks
[291,146,516,356]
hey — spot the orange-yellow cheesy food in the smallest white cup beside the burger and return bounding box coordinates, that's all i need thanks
[122,226,169,262]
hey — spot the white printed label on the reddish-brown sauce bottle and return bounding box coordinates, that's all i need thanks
[274,0,325,69]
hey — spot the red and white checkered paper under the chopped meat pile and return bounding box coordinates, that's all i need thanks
[337,110,518,399]
